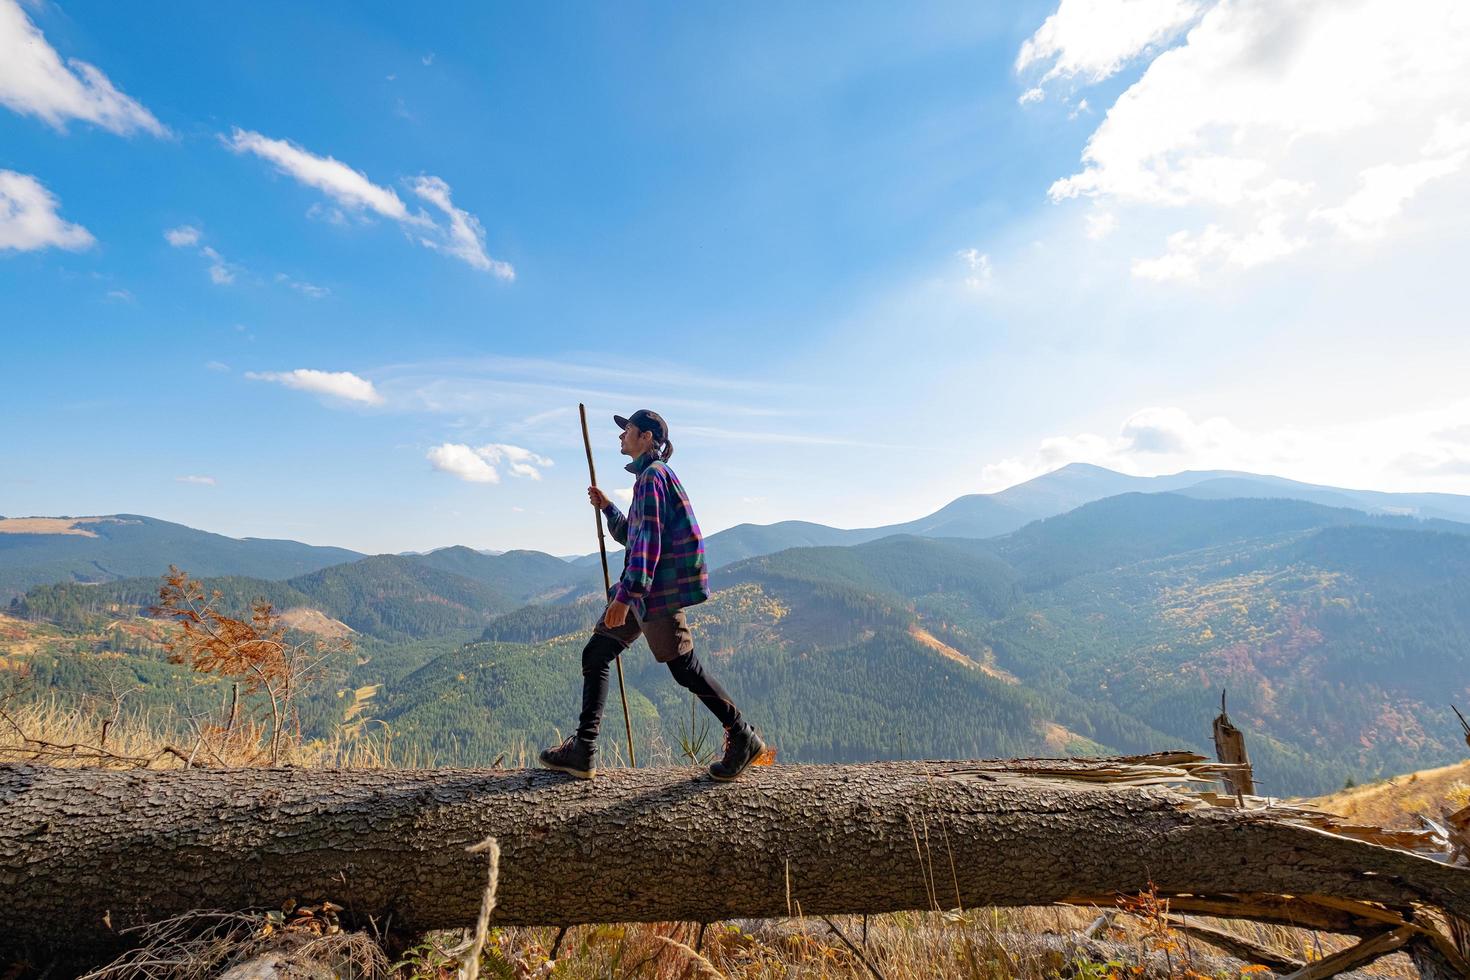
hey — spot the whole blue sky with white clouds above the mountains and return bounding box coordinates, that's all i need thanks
[0,0,1470,552]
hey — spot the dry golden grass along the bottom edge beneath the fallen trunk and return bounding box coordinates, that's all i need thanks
[395,907,1419,980]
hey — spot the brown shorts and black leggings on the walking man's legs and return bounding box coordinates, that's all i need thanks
[576,611,741,741]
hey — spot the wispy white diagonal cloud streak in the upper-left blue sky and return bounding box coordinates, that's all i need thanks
[221,126,516,281]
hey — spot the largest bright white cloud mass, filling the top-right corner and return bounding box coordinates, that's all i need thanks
[1017,0,1470,281]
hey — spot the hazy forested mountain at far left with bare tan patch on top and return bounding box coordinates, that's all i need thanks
[0,514,362,602]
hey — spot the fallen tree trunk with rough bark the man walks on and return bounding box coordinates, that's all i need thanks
[0,757,1470,945]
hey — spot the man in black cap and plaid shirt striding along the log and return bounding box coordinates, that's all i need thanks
[541,408,766,780]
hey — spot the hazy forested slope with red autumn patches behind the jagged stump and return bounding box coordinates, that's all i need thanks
[985,526,1470,792]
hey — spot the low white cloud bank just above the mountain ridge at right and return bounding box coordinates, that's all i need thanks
[980,400,1470,492]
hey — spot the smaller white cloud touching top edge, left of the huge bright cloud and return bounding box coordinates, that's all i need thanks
[1016,0,1202,87]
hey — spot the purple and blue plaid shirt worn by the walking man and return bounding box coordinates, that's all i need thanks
[603,453,710,620]
